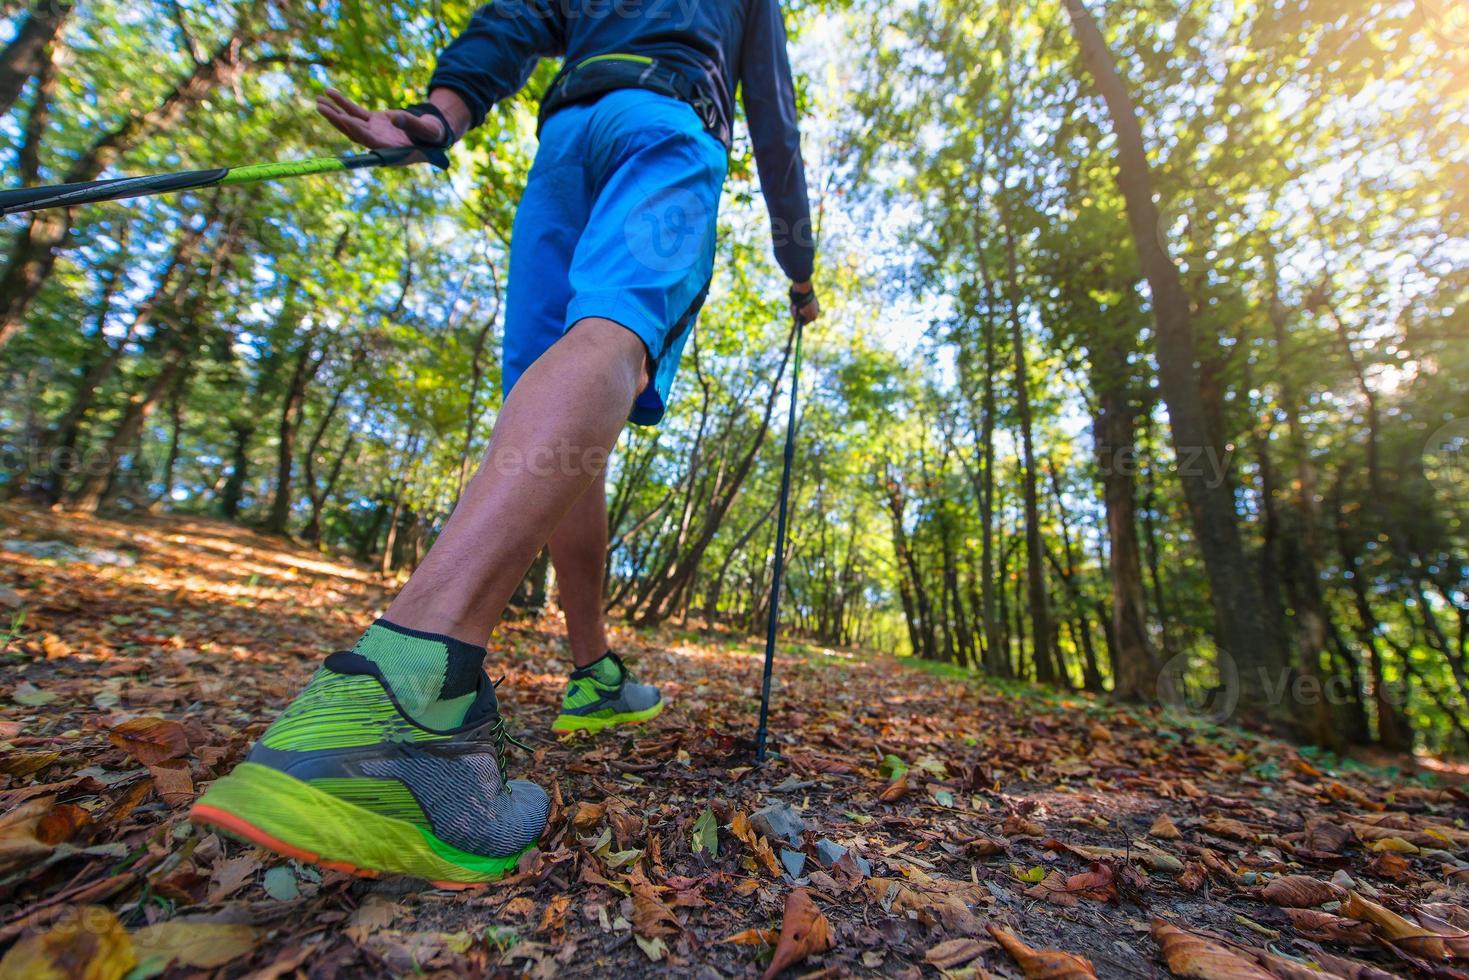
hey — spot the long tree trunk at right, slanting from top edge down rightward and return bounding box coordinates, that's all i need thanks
[1065,0,1285,723]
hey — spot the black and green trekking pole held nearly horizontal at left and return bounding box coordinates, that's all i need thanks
[0,147,417,215]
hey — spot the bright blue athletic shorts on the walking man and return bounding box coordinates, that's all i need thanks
[501,88,727,425]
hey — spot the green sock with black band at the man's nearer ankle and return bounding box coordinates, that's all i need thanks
[353,620,485,719]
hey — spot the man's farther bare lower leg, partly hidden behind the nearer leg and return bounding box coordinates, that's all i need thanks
[551,479,607,667]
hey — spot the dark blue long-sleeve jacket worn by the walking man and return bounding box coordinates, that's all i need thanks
[429,0,815,282]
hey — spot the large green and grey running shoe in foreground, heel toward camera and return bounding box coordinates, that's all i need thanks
[190,652,551,887]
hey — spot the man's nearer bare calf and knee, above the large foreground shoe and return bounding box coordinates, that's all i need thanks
[385,317,648,646]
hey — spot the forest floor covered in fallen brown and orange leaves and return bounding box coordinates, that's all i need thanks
[0,508,1469,980]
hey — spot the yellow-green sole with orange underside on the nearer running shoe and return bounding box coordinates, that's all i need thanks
[190,763,536,889]
